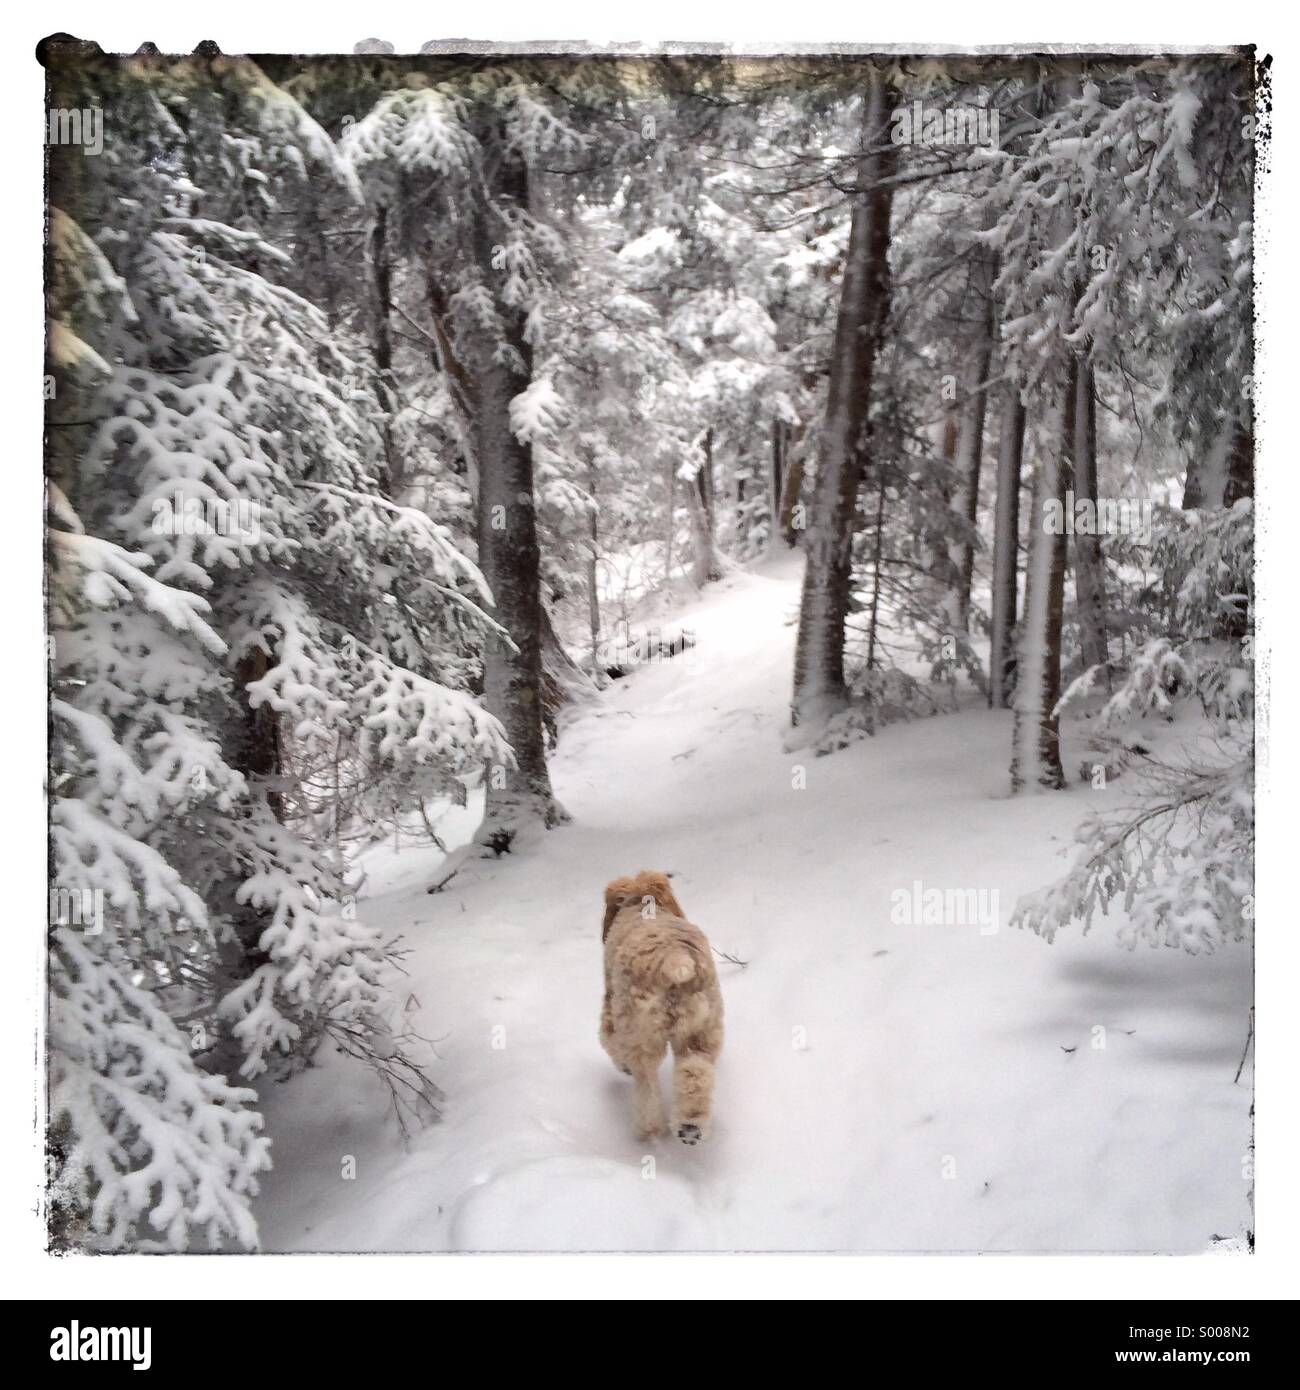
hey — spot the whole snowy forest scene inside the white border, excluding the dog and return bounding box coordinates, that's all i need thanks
[42,36,1268,1251]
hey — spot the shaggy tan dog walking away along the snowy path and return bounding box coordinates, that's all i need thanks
[601,869,723,1144]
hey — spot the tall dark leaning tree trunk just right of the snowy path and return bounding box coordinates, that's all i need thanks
[791,68,897,733]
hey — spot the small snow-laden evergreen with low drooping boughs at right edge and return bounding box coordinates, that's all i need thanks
[1015,499,1254,952]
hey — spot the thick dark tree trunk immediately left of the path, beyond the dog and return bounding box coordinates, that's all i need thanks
[470,117,569,853]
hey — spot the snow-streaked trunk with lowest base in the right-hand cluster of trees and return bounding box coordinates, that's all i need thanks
[1011,353,1079,791]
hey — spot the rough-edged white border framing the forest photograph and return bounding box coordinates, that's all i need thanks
[0,0,1300,1300]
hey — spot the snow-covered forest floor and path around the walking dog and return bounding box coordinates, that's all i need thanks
[248,547,1251,1252]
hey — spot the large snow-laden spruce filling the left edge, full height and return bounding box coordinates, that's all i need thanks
[41,58,510,1248]
